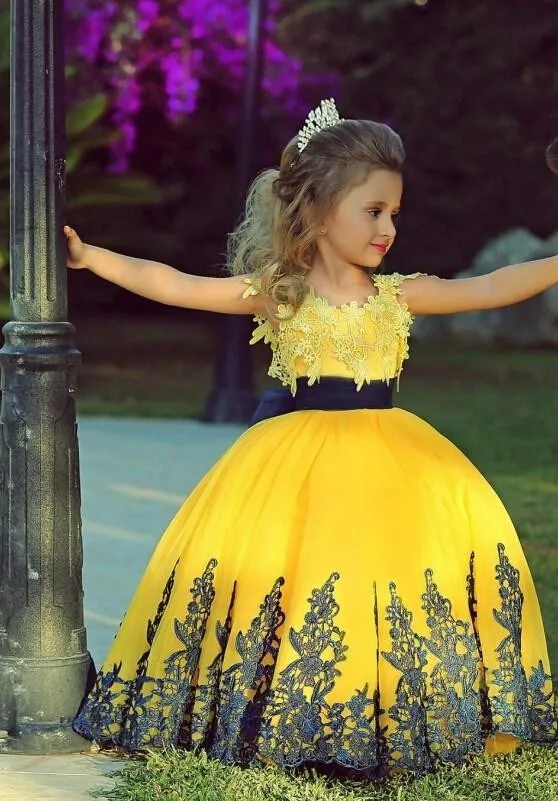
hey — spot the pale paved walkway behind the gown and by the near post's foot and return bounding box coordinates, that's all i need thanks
[0,418,242,801]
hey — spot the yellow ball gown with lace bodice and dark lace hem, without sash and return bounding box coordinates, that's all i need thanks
[74,274,558,777]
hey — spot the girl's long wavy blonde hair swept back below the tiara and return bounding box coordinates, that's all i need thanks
[227,120,405,308]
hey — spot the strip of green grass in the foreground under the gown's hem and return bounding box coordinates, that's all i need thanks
[95,746,558,801]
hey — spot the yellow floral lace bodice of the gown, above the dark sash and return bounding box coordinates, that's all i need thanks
[243,273,424,395]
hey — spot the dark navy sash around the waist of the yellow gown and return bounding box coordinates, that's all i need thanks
[250,376,394,425]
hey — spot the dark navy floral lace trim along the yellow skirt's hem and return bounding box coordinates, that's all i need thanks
[74,545,558,777]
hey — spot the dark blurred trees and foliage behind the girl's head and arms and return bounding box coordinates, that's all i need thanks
[0,0,558,316]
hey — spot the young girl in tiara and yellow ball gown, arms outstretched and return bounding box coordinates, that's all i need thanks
[65,101,558,777]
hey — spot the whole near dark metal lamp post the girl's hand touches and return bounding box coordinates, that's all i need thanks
[0,0,90,753]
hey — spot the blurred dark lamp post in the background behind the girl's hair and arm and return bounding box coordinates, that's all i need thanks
[204,0,266,423]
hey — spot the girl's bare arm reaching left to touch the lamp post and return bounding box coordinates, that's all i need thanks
[64,226,265,314]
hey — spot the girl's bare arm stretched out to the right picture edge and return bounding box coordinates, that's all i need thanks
[401,256,558,314]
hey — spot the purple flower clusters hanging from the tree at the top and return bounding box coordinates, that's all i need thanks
[66,0,312,171]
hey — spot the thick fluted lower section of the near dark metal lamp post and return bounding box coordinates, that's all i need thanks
[0,322,92,753]
